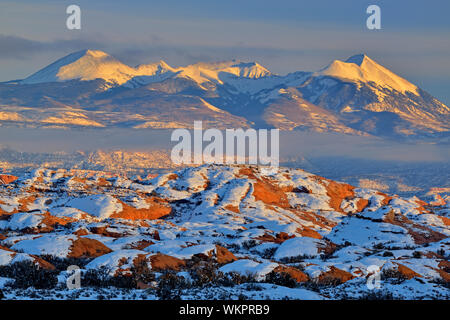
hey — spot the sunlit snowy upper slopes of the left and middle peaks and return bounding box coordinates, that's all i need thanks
[21,50,270,87]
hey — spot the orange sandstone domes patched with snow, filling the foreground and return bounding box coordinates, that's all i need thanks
[0,166,450,299]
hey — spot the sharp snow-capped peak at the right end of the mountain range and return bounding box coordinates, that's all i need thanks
[299,55,450,136]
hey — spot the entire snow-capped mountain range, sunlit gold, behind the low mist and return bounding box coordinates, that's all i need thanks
[0,50,450,137]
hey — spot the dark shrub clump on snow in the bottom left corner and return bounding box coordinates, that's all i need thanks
[0,261,58,289]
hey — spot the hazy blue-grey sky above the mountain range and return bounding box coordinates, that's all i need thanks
[0,0,450,105]
